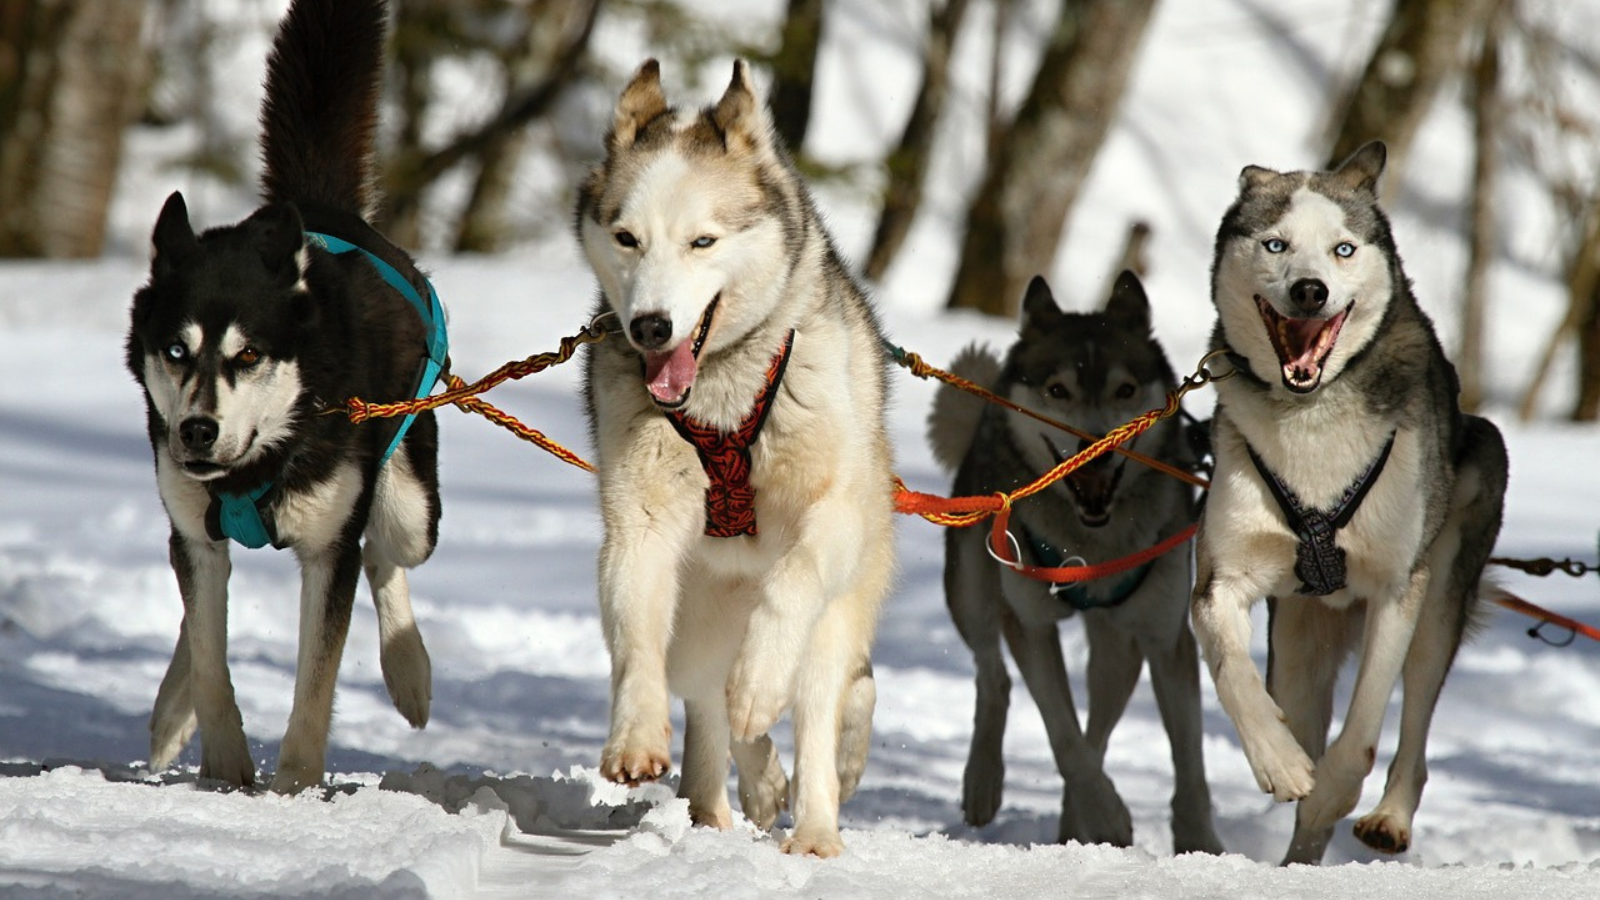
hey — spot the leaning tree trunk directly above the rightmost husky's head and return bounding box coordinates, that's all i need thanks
[1328,0,1488,185]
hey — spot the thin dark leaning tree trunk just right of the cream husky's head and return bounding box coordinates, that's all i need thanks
[862,0,966,282]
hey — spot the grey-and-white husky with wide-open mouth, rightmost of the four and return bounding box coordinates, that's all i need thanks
[1194,143,1507,863]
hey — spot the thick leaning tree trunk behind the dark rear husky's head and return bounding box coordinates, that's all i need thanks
[947,0,1155,317]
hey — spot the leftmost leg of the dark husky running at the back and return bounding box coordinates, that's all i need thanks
[944,528,1011,826]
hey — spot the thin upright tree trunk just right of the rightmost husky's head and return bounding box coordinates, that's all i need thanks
[1456,0,1506,412]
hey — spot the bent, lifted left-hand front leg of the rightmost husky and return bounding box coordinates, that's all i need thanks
[1192,560,1315,802]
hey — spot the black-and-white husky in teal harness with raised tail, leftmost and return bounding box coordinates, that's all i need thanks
[128,0,445,793]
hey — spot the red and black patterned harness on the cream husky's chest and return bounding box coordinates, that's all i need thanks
[666,330,795,538]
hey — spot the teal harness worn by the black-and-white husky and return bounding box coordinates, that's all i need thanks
[206,231,450,549]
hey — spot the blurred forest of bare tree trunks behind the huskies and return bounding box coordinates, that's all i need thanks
[0,0,1600,420]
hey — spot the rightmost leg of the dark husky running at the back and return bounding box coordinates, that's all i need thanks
[1139,614,1222,854]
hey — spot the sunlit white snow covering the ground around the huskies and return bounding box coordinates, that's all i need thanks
[0,0,1600,898]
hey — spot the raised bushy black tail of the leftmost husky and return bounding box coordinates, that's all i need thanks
[261,0,389,218]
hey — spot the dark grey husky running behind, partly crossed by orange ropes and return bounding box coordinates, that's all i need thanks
[928,272,1222,854]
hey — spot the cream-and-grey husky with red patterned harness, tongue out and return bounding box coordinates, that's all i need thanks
[576,61,894,857]
